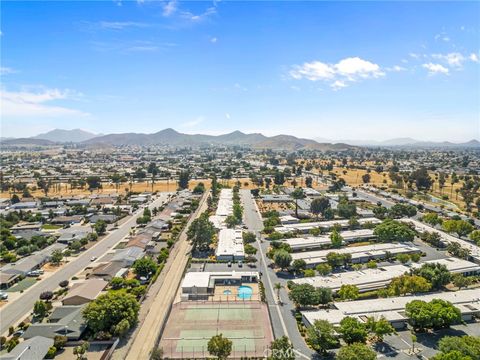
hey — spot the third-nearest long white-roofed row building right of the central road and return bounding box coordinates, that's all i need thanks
[292,243,420,267]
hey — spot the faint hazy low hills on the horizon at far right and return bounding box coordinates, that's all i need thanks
[316,137,480,148]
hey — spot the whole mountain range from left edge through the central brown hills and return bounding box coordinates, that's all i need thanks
[2,128,353,150]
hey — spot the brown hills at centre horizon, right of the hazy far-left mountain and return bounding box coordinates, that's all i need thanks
[83,129,352,150]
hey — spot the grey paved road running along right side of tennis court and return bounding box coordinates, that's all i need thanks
[240,190,315,359]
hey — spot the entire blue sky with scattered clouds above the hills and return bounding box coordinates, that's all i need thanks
[0,0,480,141]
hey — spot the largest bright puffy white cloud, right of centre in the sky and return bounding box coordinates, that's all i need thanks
[289,57,385,90]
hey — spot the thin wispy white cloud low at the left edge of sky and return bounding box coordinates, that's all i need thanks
[0,89,88,117]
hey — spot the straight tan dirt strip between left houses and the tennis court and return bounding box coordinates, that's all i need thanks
[122,193,208,360]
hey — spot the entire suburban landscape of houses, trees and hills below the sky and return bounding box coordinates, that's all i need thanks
[0,130,480,360]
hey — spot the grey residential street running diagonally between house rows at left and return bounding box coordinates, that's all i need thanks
[0,193,172,334]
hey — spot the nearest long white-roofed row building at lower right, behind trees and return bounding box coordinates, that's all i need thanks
[302,289,480,329]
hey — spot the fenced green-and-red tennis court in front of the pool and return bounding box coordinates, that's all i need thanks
[160,301,273,358]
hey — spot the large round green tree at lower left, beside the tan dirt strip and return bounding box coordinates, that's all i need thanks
[83,292,140,333]
